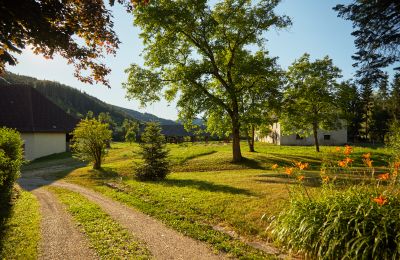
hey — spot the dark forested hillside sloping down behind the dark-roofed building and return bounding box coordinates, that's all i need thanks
[0,72,178,125]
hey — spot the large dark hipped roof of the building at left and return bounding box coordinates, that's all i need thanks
[0,85,79,133]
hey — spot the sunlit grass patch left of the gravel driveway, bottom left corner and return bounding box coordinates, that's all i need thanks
[0,189,41,259]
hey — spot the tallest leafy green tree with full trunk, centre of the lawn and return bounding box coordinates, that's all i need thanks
[124,0,290,162]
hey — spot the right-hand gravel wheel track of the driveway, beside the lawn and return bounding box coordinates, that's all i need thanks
[51,181,225,259]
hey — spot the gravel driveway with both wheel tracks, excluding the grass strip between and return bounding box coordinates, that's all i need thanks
[18,174,226,259]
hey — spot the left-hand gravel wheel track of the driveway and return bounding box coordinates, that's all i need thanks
[19,180,97,260]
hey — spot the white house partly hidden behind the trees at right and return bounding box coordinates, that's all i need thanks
[256,123,347,146]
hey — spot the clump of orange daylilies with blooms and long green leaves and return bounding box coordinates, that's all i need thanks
[269,146,400,259]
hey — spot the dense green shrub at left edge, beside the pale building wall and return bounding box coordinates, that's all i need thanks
[0,127,23,200]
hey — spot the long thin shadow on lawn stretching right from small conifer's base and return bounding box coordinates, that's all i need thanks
[159,179,255,196]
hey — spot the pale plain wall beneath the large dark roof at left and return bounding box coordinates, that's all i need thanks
[21,133,66,160]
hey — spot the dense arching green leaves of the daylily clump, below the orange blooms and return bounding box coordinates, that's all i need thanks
[272,187,400,259]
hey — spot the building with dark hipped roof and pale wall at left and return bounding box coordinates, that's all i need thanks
[0,84,78,160]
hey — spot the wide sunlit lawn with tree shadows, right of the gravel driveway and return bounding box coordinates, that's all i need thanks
[21,140,389,258]
